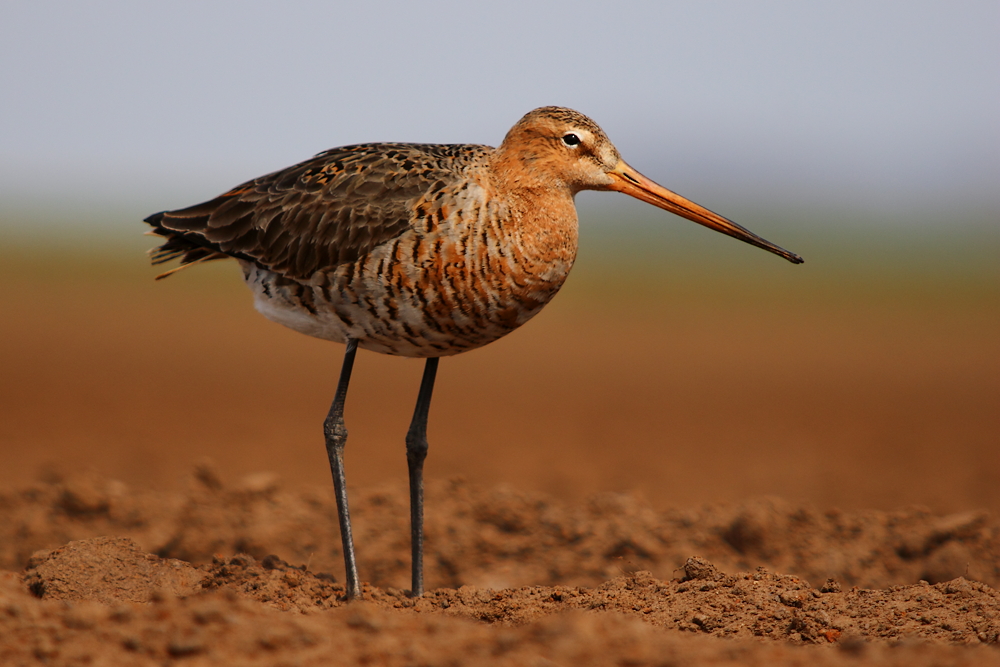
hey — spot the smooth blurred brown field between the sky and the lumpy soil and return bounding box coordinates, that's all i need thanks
[0,217,1000,512]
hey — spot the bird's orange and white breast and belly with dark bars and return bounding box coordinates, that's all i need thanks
[241,175,577,357]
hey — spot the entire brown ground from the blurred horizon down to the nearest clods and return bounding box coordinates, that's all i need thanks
[0,234,1000,665]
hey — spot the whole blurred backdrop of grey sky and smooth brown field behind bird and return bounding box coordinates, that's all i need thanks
[0,0,1000,511]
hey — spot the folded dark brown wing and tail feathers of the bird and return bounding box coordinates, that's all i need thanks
[145,144,491,280]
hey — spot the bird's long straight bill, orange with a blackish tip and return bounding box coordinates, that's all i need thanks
[608,160,804,264]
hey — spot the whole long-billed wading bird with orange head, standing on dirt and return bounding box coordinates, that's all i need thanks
[144,106,803,600]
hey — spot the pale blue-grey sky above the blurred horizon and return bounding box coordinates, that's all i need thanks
[0,0,1000,234]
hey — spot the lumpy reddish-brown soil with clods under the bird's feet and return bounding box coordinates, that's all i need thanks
[0,467,1000,665]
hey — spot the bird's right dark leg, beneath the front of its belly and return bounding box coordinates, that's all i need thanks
[406,357,438,598]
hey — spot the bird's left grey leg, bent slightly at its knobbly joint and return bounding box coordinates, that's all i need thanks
[323,339,361,600]
